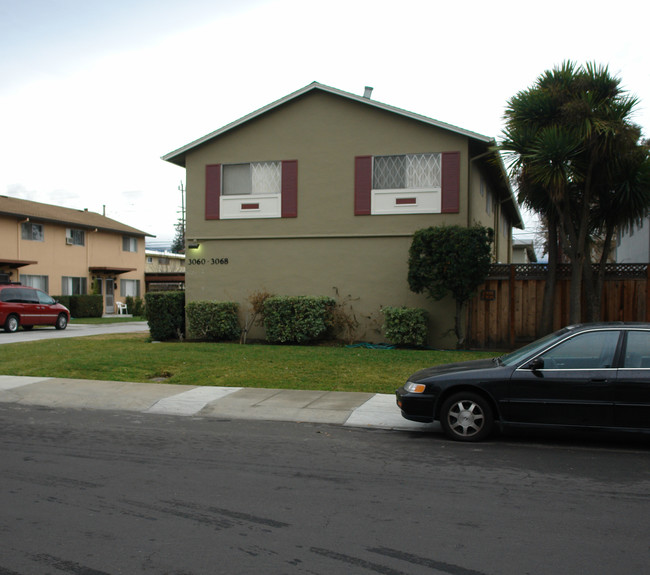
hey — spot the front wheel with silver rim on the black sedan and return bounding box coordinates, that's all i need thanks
[440,392,494,441]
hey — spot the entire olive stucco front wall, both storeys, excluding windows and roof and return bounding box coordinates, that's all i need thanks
[181,91,506,346]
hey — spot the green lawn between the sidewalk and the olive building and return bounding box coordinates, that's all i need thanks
[0,334,497,393]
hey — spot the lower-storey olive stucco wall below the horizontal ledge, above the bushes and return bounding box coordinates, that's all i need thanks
[186,237,455,347]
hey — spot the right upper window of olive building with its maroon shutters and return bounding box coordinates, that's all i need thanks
[354,152,460,215]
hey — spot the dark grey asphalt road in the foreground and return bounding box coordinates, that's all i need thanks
[0,405,650,575]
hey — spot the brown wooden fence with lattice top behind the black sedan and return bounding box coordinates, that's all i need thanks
[467,264,650,349]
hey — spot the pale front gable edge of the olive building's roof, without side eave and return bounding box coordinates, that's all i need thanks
[162,82,493,167]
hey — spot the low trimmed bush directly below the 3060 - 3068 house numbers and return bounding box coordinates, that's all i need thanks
[185,301,241,341]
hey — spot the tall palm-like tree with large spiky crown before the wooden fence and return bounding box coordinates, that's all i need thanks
[500,62,647,323]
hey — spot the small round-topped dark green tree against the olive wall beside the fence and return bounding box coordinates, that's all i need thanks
[408,226,494,347]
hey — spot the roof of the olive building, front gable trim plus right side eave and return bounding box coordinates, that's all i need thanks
[162,82,524,229]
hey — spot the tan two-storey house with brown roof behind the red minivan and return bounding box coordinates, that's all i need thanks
[0,196,150,314]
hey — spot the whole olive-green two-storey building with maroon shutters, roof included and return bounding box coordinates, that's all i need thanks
[163,83,523,345]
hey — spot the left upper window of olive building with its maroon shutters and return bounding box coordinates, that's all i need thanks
[205,160,298,220]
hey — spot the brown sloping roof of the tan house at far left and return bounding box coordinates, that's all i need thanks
[0,196,155,237]
